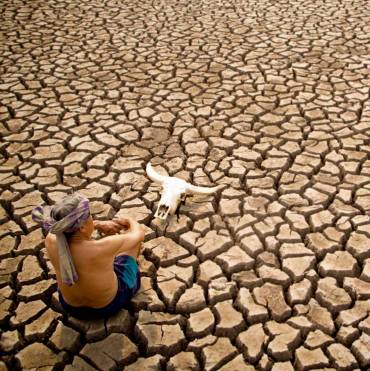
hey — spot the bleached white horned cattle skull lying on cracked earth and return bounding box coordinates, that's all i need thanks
[146,162,219,219]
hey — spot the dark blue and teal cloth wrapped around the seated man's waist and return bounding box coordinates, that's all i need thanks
[59,255,140,319]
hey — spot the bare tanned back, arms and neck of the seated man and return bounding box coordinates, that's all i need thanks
[45,219,144,308]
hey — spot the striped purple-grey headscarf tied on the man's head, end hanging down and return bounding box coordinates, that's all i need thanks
[32,194,90,286]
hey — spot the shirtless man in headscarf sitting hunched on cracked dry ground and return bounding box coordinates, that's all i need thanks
[33,194,144,319]
